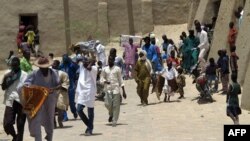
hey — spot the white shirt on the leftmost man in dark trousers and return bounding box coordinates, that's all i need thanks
[3,70,27,107]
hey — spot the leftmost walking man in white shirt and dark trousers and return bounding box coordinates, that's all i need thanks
[2,57,27,141]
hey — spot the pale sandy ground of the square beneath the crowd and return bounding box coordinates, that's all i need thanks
[0,24,250,141]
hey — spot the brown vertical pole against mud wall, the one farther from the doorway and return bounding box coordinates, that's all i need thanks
[127,0,135,35]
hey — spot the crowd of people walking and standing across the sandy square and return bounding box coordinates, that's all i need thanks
[1,18,244,141]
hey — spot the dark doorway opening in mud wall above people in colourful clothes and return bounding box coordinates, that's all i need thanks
[19,13,38,30]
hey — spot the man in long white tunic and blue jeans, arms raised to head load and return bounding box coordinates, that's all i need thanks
[76,57,97,135]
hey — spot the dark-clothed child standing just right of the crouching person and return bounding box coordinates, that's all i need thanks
[206,58,218,92]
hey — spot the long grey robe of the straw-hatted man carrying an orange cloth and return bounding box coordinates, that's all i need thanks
[24,69,60,141]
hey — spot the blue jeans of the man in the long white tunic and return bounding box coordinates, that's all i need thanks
[77,104,94,133]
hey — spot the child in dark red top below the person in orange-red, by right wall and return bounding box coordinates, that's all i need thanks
[230,46,239,76]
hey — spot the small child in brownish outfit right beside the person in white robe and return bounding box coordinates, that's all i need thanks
[176,67,186,99]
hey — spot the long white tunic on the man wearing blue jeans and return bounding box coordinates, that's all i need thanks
[76,64,97,107]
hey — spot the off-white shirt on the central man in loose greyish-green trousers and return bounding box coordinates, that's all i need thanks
[101,66,124,94]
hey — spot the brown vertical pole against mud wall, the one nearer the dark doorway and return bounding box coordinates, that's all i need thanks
[63,0,71,53]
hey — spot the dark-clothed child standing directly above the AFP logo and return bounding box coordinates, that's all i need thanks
[226,74,241,125]
